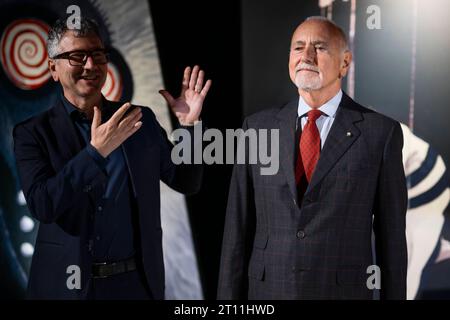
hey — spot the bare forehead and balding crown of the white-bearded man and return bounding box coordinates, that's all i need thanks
[291,20,340,46]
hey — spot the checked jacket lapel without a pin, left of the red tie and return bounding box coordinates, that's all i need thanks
[277,99,298,198]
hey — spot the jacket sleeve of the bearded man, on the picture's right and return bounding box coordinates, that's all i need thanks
[374,122,408,300]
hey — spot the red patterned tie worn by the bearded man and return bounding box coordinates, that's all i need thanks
[295,110,322,183]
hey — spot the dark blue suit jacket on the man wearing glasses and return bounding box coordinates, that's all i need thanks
[13,98,202,299]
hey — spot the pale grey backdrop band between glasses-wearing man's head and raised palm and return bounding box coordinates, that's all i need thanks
[91,0,171,132]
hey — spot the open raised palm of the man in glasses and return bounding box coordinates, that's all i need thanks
[159,66,211,125]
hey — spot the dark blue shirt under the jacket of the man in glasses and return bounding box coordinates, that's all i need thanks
[62,96,137,262]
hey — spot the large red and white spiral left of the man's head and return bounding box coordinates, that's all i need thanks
[0,19,50,90]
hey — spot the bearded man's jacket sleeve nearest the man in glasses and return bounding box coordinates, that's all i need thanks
[217,120,256,300]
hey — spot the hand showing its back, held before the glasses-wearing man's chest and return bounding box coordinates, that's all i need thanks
[91,102,142,158]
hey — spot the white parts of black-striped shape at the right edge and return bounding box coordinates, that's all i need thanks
[401,124,450,300]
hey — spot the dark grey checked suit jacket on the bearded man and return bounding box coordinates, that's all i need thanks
[218,94,407,300]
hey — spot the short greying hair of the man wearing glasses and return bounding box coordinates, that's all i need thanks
[47,17,104,58]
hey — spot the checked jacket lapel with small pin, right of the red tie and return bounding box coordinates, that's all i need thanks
[305,93,363,195]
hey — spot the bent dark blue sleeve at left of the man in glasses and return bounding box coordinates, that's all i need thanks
[13,124,106,223]
